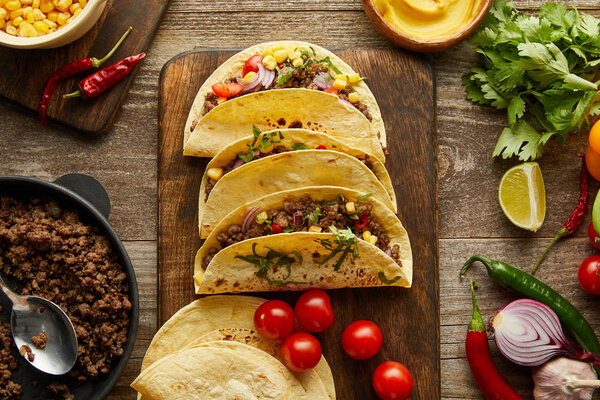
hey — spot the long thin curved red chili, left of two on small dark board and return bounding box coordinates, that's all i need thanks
[38,27,132,126]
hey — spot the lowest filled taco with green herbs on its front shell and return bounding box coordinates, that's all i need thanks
[194,186,412,294]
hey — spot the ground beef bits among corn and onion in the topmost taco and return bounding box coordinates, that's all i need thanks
[202,56,373,122]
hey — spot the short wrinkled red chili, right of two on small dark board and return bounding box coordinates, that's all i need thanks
[63,53,146,99]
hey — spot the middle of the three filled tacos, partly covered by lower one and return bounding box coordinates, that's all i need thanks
[198,129,397,239]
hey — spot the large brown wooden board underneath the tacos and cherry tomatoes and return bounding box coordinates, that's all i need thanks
[158,49,440,400]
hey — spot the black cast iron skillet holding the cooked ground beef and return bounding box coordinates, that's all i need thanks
[0,174,140,400]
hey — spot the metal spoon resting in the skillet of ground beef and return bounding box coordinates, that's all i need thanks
[0,277,77,375]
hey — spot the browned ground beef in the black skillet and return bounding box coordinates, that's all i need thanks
[0,197,132,393]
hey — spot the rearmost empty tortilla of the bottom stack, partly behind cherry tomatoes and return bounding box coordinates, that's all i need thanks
[138,295,335,399]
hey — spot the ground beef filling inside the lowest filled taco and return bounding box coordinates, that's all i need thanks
[202,195,400,269]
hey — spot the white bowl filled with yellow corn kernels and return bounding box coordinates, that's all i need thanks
[0,0,107,49]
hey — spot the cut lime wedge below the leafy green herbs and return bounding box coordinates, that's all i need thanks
[498,162,546,232]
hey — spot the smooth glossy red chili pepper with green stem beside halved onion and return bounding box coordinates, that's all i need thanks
[465,281,523,400]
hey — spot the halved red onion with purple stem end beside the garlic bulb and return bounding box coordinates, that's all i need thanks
[492,299,600,367]
